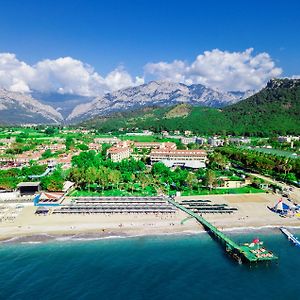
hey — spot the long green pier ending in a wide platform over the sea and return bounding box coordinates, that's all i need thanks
[168,198,278,263]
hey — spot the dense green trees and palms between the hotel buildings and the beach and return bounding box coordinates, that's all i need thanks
[68,151,260,196]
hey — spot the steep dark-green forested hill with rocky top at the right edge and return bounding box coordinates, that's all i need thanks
[224,79,300,134]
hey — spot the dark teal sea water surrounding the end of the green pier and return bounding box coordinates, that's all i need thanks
[0,230,300,300]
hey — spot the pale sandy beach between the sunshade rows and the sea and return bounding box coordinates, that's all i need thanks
[0,194,300,241]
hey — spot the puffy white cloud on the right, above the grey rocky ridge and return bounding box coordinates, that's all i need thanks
[144,48,282,91]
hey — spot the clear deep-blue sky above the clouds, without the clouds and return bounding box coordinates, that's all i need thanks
[0,0,300,95]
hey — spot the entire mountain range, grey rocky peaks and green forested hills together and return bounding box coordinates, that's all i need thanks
[0,79,300,135]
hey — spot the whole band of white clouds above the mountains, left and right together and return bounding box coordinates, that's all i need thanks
[0,48,288,96]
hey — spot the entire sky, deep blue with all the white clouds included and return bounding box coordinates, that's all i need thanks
[0,0,300,96]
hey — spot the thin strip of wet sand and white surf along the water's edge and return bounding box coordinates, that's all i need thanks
[0,225,300,247]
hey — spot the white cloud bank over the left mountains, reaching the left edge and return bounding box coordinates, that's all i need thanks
[0,53,143,96]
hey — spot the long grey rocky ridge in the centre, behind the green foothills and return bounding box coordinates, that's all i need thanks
[66,81,254,122]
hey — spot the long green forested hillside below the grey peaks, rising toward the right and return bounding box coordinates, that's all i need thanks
[83,79,300,135]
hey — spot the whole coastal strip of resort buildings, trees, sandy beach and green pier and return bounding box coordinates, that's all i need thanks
[0,127,300,263]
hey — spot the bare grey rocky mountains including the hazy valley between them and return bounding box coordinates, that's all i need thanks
[0,81,254,124]
